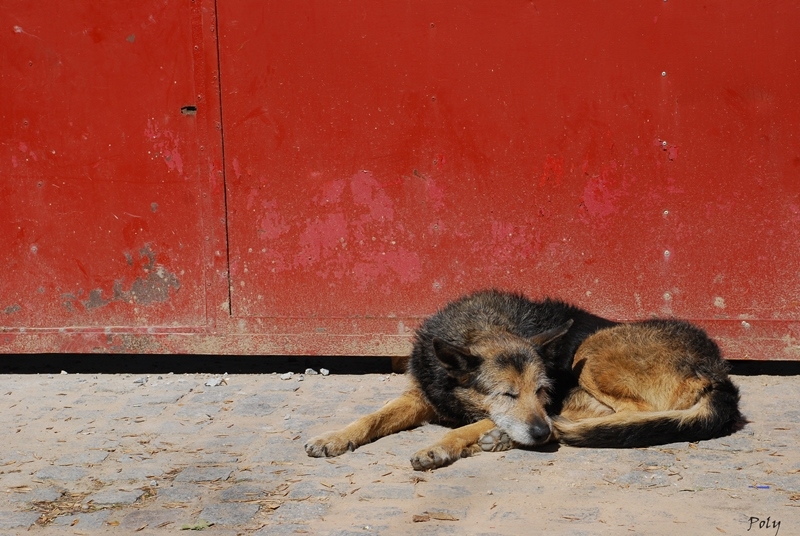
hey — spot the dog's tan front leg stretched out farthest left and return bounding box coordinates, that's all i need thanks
[305,388,436,458]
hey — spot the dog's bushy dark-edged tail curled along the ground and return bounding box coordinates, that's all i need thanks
[553,379,742,448]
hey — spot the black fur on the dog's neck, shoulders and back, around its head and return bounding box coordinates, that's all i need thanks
[409,290,616,426]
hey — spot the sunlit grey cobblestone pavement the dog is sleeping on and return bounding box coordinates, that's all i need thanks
[0,374,800,536]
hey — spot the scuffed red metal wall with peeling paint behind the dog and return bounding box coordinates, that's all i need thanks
[0,0,800,359]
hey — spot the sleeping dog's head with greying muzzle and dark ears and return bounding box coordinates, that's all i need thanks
[433,320,572,445]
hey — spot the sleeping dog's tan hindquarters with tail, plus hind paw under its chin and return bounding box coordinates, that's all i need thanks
[481,320,743,450]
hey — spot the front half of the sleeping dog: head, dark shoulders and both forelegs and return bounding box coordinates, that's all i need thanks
[305,291,613,470]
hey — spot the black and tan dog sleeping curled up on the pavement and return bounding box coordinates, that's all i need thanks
[305,291,741,470]
